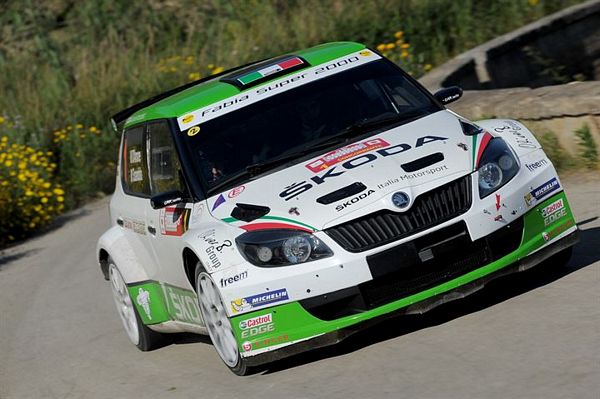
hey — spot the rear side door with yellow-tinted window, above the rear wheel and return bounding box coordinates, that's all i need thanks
[111,125,158,283]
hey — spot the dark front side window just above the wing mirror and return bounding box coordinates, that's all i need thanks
[148,121,184,195]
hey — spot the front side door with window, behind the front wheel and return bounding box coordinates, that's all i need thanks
[146,120,202,324]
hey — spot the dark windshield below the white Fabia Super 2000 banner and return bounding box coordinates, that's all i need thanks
[186,60,440,194]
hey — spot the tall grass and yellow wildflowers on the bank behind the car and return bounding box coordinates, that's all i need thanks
[0,0,591,246]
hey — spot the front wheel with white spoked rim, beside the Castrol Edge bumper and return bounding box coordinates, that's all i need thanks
[196,266,249,375]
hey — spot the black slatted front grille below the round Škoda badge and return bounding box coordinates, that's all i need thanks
[325,176,471,252]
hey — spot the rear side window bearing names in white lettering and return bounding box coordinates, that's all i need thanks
[122,126,150,196]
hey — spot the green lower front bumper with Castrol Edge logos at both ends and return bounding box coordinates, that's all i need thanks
[231,192,577,365]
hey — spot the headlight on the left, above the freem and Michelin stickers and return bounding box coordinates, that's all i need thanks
[235,230,333,267]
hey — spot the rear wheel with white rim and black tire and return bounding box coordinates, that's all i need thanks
[108,258,168,352]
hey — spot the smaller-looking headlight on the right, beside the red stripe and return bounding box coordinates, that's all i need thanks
[478,138,519,198]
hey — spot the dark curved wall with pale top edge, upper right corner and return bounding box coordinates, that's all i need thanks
[420,0,600,90]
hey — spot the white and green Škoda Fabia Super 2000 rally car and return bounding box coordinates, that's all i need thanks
[97,42,577,375]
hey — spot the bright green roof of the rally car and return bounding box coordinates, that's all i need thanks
[122,42,365,128]
